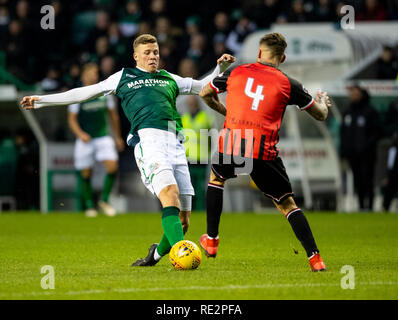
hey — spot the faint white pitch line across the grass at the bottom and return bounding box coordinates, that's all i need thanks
[0,281,398,298]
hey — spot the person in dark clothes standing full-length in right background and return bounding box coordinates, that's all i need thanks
[340,85,380,211]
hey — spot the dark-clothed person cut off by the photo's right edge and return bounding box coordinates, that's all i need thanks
[383,100,398,211]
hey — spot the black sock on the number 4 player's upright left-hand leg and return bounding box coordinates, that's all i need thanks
[206,183,224,238]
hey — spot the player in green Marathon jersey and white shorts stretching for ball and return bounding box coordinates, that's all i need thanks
[21,34,235,266]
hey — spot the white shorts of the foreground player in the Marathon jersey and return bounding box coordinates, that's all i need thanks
[134,129,195,196]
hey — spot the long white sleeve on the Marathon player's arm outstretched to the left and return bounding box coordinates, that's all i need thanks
[34,71,122,109]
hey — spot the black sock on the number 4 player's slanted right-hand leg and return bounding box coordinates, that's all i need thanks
[287,209,319,257]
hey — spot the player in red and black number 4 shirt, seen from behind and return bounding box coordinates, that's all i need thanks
[200,33,331,271]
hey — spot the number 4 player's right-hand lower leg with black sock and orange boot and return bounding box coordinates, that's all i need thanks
[274,197,326,272]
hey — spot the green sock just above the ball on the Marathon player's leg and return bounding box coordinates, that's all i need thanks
[162,206,184,247]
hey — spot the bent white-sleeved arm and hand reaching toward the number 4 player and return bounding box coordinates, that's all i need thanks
[170,61,231,95]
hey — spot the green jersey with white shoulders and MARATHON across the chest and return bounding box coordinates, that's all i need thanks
[99,68,192,138]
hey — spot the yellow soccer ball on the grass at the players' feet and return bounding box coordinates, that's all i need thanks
[169,240,202,270]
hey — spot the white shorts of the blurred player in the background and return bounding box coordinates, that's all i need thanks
[74,136,118,170]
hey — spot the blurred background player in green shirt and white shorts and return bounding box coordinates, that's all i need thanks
[68,63,124,217]
